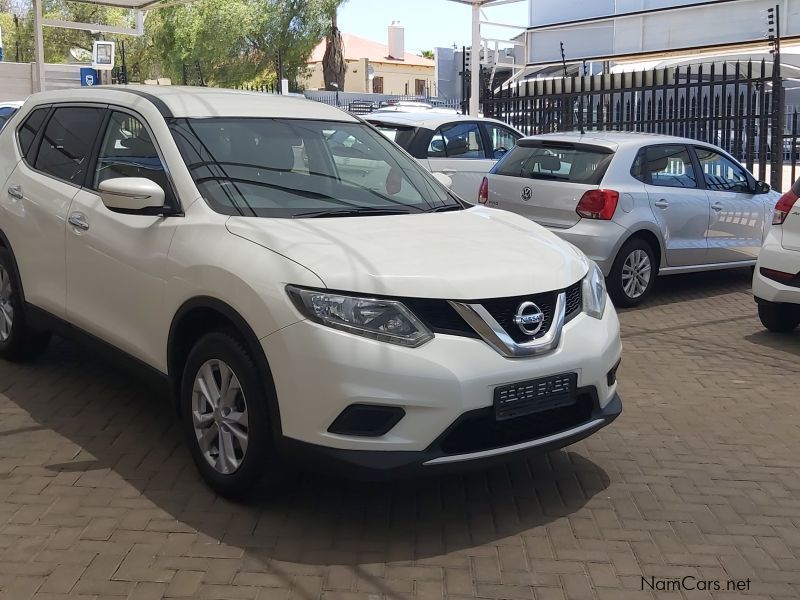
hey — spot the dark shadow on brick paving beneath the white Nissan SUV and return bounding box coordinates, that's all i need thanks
[0,339,610,576]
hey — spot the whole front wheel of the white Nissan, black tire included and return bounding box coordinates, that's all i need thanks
[180,331,277,499]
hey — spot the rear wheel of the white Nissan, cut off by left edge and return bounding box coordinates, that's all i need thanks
[0,248,50,362]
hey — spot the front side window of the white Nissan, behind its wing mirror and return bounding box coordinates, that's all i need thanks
[92,112,171,197]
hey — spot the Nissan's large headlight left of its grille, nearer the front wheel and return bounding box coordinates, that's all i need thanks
[286,285,433,348]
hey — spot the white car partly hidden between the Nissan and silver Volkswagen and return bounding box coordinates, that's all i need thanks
[365,111,522,204]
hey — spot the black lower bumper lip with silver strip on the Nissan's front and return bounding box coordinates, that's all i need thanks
[279,388,622,481]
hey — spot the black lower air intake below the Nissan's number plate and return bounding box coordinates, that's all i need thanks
[434,388,595,455]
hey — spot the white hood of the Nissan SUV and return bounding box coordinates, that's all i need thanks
[227,207,587,300]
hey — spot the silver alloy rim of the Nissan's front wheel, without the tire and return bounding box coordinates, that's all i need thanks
[192,359,249,475]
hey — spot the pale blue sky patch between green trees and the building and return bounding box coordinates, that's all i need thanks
[339,0,528,54]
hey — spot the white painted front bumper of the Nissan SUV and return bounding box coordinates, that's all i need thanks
[262,302,622,462]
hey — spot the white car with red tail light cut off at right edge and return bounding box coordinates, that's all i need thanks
[753,180,800,332]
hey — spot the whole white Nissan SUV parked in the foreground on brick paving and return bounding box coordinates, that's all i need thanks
[0,86,621,496]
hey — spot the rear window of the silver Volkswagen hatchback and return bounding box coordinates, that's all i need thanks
[492,140,614,185]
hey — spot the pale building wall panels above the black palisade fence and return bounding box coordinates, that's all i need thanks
[528,0,800,64]
